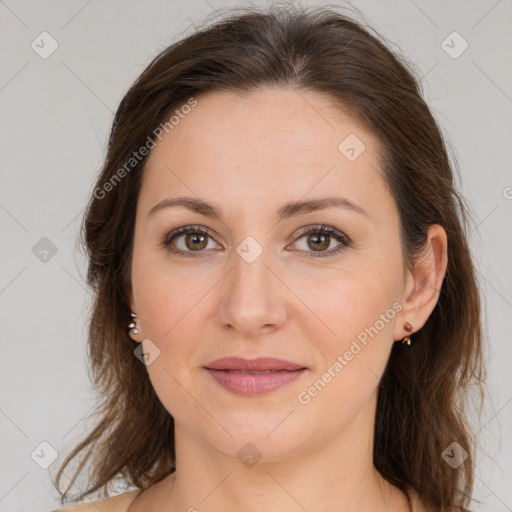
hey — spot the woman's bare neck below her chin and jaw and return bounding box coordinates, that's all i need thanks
[153,392,409,512]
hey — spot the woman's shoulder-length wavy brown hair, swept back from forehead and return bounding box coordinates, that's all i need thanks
[56,3,486,511]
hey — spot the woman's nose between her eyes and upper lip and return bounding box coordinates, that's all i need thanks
[219,244,287,338]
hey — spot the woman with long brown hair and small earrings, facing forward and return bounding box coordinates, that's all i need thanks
[50,6,484,512]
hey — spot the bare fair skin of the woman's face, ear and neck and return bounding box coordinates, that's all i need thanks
[129,88,447,512]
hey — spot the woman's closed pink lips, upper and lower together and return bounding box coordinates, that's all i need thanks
[205,357,307,396]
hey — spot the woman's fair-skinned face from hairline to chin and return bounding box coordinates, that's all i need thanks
[130,88,406,460]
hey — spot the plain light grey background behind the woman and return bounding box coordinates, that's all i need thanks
[0,0,512,512]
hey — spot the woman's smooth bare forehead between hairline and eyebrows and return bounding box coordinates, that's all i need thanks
[139,87,390,218]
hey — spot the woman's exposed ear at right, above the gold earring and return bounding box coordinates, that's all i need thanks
[395,224,448,340]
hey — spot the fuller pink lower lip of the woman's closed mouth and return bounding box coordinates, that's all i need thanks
[206,368,306,396]
